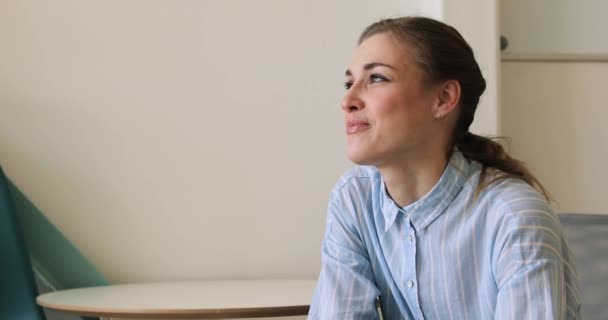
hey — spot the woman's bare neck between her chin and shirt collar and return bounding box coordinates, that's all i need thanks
[378,152,447,207]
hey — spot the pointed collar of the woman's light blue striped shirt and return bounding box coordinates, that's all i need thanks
[380,150,470,232]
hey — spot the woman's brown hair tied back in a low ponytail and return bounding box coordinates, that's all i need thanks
[359,17,550,200]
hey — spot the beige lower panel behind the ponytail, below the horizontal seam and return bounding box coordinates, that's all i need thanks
[501,62,608,213]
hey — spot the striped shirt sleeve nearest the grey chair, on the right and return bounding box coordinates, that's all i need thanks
[493,199,579,320]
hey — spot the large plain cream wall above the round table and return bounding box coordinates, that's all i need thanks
[0,0,418,282]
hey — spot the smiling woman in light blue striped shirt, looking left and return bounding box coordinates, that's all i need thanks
[309,17,580,320]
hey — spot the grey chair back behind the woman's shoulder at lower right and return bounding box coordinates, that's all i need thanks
[558,214,608,320]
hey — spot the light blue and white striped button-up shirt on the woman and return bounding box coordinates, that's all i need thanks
[308,152,580,320]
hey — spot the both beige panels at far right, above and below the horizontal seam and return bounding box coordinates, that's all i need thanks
[501,0,608,213]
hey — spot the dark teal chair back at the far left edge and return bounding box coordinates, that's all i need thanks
[0,168,45,320]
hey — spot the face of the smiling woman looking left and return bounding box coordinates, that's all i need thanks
[342,33,436,166]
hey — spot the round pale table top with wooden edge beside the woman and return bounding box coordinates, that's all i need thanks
[36,280,316,319]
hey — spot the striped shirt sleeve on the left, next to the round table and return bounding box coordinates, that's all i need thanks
[308,191,380,320]
